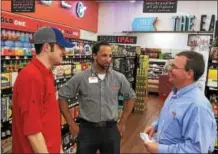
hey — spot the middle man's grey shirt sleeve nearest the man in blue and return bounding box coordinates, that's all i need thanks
[120,74,136,100]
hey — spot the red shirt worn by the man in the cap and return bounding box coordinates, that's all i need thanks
[12,58,61,153]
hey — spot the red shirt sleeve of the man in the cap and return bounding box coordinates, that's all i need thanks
[17,78,43,136]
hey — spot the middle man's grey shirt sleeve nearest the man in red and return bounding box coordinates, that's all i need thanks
[58,74,82,100]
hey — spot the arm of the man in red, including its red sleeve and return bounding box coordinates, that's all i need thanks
[17,78,48,153]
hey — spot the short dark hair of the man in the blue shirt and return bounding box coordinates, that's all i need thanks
[177,51,205,81]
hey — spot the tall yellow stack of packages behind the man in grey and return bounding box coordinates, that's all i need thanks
[135,55,149,112]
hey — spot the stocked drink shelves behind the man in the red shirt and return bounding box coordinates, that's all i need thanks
[1,13,94,153]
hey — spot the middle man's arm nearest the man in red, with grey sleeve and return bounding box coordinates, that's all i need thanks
[58,74,80,136]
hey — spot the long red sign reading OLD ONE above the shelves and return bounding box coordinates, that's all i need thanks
[1,11,80,38]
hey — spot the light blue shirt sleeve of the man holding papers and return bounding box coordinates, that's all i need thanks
[158,104,217,153]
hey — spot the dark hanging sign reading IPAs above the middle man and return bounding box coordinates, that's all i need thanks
[98,35,137,44]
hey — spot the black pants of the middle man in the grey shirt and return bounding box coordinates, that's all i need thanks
[77,120,120,154]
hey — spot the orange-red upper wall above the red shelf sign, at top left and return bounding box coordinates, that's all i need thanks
[1,0,98,33]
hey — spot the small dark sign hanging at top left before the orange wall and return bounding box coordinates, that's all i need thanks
[11,0,35,12]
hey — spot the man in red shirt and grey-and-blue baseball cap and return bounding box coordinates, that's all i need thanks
[12,27,72,153]
